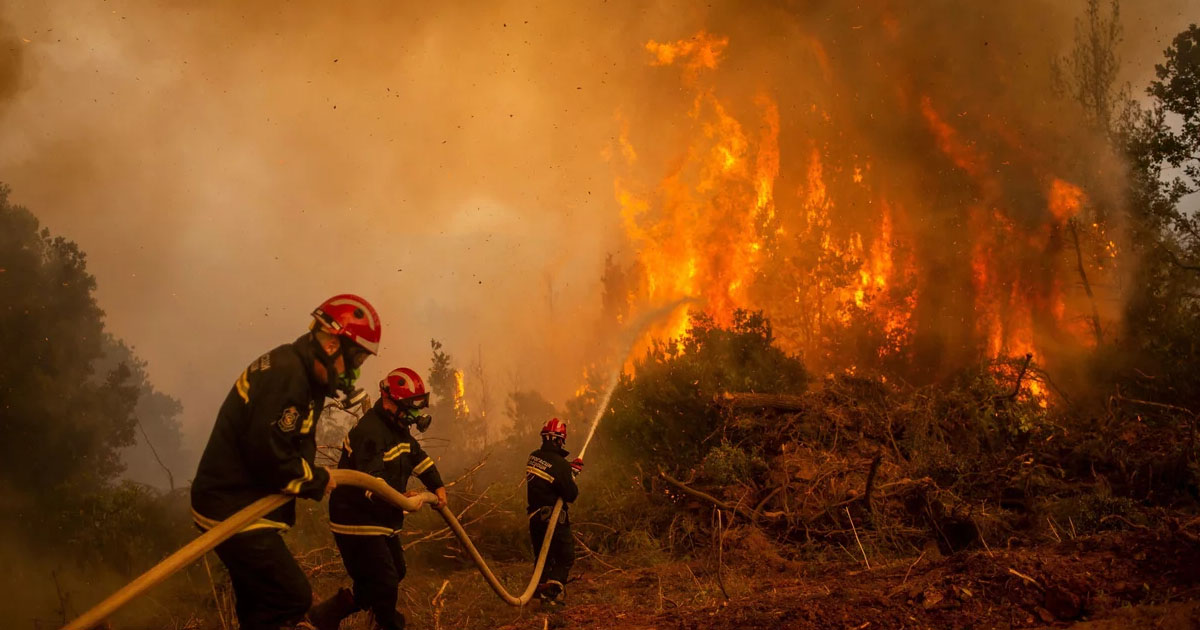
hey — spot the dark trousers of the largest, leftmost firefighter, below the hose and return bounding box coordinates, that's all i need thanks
[216,529,312,630]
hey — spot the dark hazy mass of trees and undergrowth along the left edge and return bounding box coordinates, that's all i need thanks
[0,185,178,570]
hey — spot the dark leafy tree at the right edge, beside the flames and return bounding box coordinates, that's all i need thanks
[1116,25,1200,407]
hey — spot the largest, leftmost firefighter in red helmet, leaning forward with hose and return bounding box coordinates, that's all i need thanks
[192,294,380,630]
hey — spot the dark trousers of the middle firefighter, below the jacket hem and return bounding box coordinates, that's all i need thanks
[334,534,407,630]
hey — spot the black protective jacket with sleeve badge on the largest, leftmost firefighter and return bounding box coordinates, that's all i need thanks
[192,334,329,530]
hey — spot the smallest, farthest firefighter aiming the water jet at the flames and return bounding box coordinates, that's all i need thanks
[526,418,583,604]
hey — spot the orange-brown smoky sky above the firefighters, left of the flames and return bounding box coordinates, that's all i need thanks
[0,0,1200,451]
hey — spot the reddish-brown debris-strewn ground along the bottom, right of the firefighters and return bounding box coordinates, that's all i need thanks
[333,530,1200,630]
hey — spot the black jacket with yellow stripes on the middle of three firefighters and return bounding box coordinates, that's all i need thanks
[329,400,443,535]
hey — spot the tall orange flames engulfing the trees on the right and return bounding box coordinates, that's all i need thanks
[607,31,1116,400]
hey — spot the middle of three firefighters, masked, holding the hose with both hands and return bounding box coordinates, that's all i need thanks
[308,367,446,630]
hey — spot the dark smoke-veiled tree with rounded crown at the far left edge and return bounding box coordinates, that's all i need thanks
[0,185,138,497]
